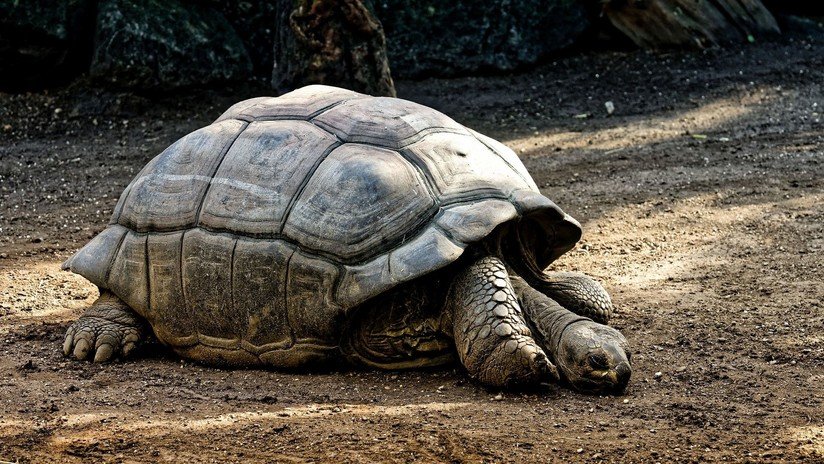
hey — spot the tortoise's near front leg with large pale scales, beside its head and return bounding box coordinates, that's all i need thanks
[447,257,558,387]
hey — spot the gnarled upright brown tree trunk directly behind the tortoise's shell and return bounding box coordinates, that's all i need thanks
[272,0,395,96]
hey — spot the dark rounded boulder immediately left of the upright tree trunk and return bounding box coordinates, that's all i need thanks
[90,0,252,89]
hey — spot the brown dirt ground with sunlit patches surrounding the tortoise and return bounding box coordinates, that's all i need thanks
[0,31,824,463]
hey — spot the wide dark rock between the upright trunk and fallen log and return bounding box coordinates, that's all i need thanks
[375,0,589,78]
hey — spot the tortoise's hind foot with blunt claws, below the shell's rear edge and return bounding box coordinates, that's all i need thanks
[63,289,146,362]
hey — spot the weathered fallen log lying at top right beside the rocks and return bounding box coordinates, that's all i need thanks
[603,0,781,49]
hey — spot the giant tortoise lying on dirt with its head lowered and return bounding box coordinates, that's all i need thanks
[63,85,631,391]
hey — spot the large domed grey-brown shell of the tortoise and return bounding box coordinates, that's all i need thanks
[64,85,580,365]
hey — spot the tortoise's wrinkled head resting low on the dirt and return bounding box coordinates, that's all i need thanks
[555,320,632,392]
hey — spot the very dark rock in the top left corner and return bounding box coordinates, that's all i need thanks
[0,0,94,90]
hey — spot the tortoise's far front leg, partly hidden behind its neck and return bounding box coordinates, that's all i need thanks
[533,272,613,324]
